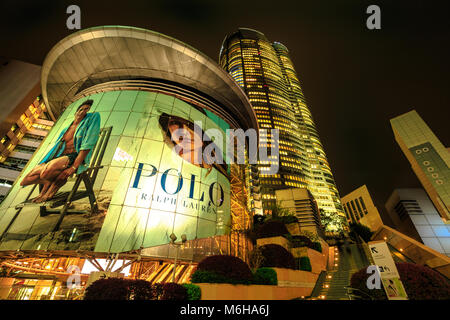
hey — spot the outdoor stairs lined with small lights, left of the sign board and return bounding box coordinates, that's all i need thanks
[311,244,370,300]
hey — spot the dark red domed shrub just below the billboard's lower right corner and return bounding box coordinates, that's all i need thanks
[196,255,253,283]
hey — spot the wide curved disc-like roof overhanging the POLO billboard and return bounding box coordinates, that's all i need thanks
[41,26,258,129]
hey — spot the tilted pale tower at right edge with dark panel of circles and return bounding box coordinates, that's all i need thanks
[391,110,450,223]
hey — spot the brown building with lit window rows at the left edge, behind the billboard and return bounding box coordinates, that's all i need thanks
[0,59,54,201]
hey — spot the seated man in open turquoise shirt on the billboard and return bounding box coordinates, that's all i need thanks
[20,100,100,203]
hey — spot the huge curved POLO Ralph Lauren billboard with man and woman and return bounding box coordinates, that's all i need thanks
[0,90,231,253]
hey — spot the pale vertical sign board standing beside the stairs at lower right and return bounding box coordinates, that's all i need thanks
[369,241,408,300]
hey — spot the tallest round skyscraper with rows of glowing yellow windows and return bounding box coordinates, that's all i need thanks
[219,28,344,229]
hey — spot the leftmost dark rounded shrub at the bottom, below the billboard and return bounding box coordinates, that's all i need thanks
[84,278,130,300]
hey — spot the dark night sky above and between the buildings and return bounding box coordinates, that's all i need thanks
[0,0,450,220]
